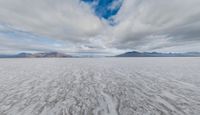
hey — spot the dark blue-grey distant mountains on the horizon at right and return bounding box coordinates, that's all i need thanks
[115,51,200,57]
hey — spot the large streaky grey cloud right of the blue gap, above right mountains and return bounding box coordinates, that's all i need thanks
[108,0,200,52]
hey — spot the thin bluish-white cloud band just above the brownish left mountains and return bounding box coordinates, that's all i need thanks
[0,25,73,53]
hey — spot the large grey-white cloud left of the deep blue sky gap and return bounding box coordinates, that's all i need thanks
[0,0,104,41]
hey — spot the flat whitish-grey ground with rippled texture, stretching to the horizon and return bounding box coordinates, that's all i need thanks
[0,58,200,115]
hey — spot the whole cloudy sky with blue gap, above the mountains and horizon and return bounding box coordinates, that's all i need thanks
[0,0,200,55]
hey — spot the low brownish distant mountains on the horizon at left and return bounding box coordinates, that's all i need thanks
[0,52,72,58]
